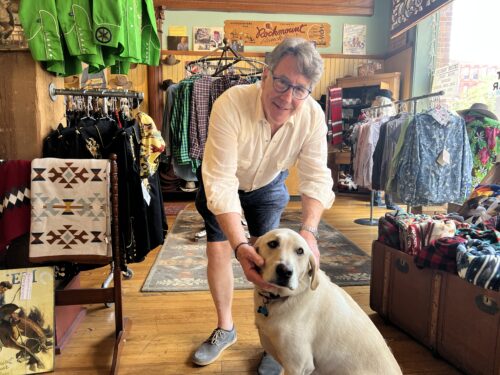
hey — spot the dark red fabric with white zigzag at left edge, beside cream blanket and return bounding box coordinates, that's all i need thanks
[0,160,31,252]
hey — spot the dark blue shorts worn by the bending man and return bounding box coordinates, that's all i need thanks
[195,167,290,242]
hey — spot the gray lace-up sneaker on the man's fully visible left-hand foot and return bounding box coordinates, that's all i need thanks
[192,326,236,366]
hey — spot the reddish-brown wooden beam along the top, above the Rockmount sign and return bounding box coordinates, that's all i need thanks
[154,0,374,16]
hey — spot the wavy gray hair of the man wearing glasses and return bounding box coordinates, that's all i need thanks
[266,38,323,84]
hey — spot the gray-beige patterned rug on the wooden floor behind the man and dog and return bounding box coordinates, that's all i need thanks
[142,208,371,292]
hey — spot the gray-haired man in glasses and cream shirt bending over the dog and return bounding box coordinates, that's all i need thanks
[193,39,335,374]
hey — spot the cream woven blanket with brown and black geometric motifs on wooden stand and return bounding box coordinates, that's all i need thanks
[29,158,111,264]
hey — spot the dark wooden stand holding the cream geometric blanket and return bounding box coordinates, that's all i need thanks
[55,154,132,374]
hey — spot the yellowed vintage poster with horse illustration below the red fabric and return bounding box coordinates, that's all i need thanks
[0,267,55,375]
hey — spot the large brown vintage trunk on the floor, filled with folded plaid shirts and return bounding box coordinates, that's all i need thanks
[370,241,500,375]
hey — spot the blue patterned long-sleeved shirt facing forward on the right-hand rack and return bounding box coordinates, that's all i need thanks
[396,109,472,206]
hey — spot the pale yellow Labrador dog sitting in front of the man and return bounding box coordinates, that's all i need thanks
[254,229,401,375]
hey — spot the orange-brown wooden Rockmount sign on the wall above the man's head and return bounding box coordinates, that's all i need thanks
[224,21,330,47]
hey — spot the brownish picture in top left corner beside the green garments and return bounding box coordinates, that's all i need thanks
[0,0,28,51]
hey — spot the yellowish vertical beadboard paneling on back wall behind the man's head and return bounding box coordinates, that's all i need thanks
[162,51,384,99]
